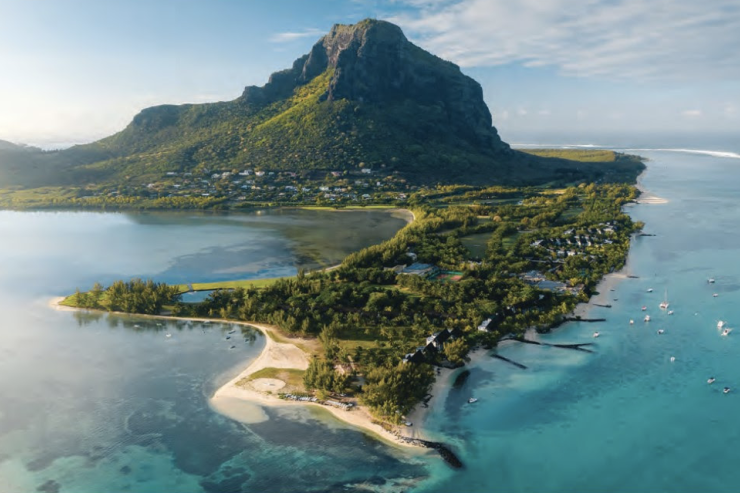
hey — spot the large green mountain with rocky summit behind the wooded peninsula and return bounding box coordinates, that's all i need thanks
[0,19,640,189]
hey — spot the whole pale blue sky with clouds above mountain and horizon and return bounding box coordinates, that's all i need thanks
[0,0,740,148]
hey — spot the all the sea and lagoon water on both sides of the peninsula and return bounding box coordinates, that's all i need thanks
[0,136,740,493]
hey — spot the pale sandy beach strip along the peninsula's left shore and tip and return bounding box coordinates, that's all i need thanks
[47,296,424,451]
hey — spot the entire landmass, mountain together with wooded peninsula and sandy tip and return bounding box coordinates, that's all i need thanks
[34,19,644,462]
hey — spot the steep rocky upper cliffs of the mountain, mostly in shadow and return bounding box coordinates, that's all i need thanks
[241,19,509,152]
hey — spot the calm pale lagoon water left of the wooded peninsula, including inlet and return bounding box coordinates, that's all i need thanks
[0,211,424,493]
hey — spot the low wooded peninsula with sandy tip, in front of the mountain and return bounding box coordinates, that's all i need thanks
[60,179,642,464]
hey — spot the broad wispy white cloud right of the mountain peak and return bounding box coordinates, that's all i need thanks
[392,0,740,79]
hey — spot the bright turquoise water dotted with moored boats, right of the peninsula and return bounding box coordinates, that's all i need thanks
[418,136,740,493]
